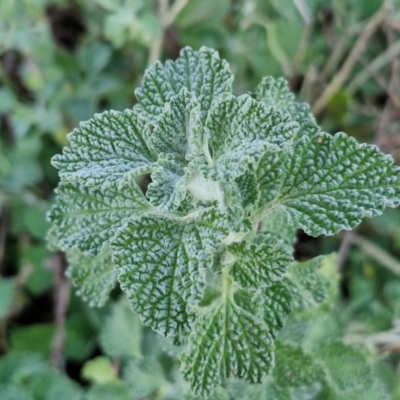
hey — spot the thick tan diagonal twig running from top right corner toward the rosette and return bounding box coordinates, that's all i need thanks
[312,2,389,115]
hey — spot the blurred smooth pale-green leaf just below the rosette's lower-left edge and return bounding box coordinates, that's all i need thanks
[100,296,143,358]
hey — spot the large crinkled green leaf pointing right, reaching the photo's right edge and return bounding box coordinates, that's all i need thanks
[259,133,400,236]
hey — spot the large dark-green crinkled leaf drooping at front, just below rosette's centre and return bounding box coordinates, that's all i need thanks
[113,208,234,336]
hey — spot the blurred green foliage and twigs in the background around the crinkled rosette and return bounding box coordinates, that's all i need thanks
[0,0,400,400]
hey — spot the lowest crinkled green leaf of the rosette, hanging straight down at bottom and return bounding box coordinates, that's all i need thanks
[181,299,274,396]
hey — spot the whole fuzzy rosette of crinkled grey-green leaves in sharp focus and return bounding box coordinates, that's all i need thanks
[49,48,400,396]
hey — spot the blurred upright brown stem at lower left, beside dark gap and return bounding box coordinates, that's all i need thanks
[50,253,70,371]
